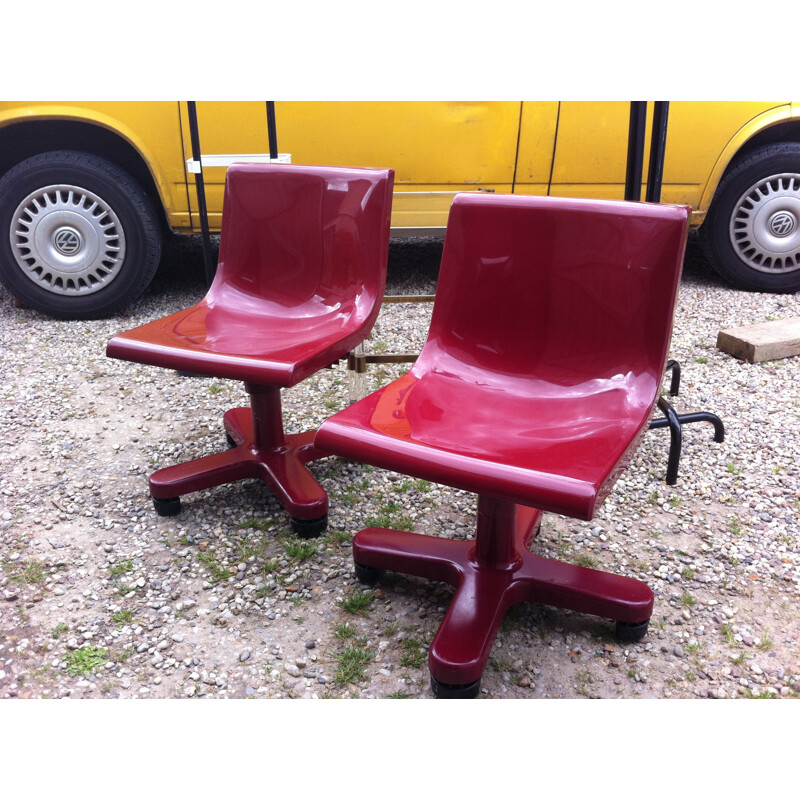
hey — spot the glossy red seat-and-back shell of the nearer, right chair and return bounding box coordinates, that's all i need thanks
[316,195,688,519]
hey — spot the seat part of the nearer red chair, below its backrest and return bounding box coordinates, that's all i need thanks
[316,362,654,519]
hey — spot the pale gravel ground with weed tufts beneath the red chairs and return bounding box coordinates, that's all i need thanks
[0,233,800,699]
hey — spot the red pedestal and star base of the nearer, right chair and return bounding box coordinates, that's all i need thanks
[353,496,653,698]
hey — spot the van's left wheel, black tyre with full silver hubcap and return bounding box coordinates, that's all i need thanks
[0,150,161,319]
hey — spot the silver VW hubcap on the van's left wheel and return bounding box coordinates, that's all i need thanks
[10,184,125,296]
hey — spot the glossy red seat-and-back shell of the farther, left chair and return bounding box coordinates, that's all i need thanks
[106,164,394,386]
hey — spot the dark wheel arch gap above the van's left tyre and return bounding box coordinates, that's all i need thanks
[0,119,169,231]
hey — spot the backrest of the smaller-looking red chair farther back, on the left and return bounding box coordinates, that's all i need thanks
[206,164,394,327]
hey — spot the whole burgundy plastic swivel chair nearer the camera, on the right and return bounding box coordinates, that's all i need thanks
[316,195,688,697]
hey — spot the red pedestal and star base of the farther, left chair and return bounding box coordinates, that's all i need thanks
[150,383,328,535]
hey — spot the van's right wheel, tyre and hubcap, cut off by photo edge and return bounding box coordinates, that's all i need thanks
[701,143,800,292]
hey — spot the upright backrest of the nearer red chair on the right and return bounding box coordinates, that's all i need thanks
[422,194,689,390]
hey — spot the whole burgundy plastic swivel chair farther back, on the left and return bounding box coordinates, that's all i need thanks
[106,164,394,536]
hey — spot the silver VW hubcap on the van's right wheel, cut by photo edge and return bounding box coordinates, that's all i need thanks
[730,173,800,274]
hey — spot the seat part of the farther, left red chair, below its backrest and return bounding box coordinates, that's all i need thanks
[107,300,362,387]
